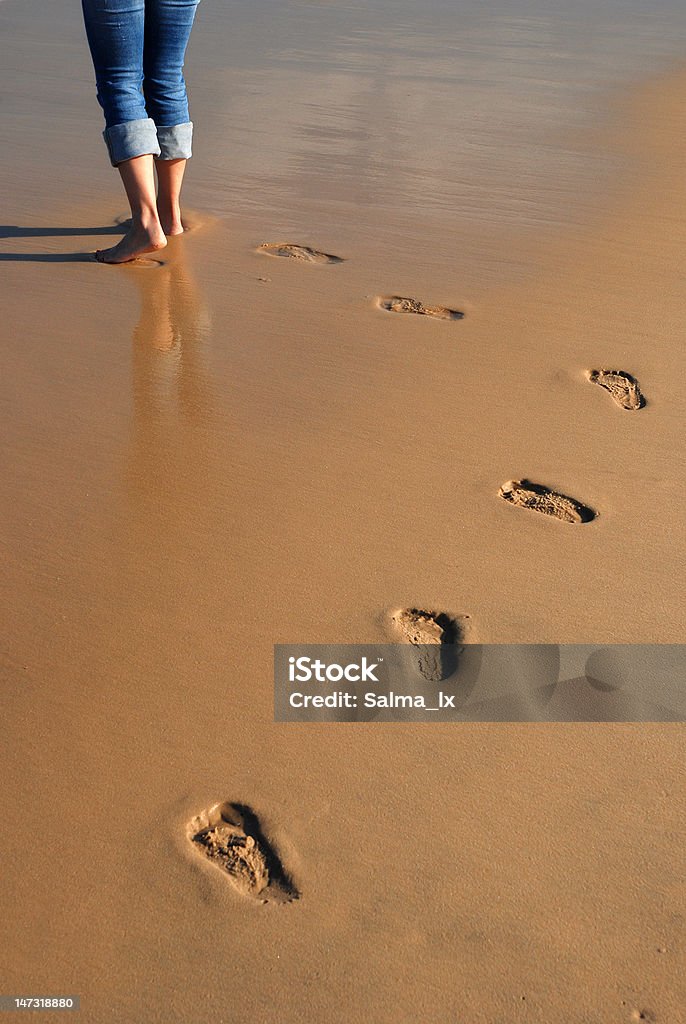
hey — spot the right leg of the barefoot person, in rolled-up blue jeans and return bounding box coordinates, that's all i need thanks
[143,0,199,234]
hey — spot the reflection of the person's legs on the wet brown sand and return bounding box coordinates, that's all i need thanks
[114,240,247,638]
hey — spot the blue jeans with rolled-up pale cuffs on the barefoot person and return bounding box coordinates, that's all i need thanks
[81,0,200,167]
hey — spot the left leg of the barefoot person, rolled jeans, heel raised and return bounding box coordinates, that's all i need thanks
[82,0,167,263]
